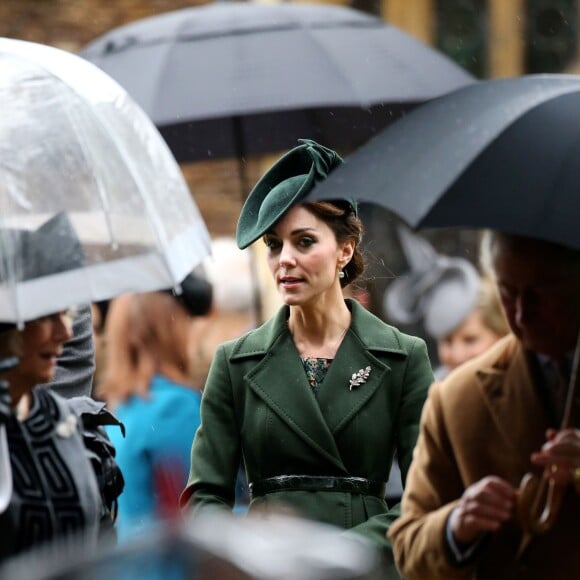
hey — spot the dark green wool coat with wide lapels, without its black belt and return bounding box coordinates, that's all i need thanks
[181,300,433,562]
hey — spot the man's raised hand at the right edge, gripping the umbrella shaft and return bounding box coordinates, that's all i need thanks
[531,429,580,486]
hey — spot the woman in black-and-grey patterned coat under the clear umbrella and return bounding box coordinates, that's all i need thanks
[0,310,123,562]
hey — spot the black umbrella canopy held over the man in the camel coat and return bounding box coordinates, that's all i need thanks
[310,75,580,249]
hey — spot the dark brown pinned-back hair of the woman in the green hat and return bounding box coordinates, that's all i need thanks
[304,201,365,288]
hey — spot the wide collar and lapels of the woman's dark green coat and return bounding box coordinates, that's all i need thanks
[230,300,407,473]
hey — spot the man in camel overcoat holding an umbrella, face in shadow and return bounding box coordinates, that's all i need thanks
[389,233,580,580]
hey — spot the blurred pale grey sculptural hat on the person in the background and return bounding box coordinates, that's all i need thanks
[383,227,480,338]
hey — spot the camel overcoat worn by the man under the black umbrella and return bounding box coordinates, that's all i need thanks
[389,335,580,580]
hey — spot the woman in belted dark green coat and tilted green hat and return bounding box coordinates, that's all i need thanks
[181,140,433,569]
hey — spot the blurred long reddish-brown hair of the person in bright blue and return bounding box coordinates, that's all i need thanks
[97,292,192,405]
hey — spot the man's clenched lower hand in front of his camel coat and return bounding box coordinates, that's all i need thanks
[449,476,516,544]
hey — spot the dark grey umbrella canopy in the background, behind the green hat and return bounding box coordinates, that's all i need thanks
[82,3,473,161]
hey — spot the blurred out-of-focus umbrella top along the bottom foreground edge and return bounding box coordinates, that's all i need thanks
[0,510,384,580]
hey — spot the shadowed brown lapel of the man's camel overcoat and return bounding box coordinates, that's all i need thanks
[478,337,548,471]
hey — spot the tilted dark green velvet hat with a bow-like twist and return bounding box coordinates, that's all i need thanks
[236,139,356,249]
